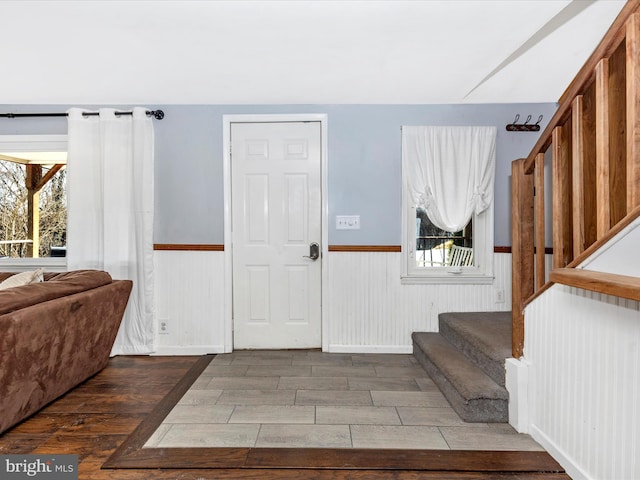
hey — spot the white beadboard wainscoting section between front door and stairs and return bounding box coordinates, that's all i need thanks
[323,252,511,353]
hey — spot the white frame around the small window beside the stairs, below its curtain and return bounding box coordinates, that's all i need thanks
[401,177,494,284]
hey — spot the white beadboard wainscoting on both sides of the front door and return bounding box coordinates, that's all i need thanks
[154,249,511,355]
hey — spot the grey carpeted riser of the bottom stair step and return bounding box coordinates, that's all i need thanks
[413,342,509,423]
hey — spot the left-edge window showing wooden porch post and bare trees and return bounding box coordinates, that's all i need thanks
[0,135,67,266]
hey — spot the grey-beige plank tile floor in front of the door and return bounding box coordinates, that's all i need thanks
[145,350,542,451]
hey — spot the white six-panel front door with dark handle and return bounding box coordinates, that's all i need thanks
[231,122,322,349]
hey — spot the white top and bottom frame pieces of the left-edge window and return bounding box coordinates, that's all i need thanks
[0,135,68,272]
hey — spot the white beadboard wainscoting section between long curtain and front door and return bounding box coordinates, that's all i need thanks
[154,250,225,355]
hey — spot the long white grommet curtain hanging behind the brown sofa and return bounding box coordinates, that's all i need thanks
[67,108,155,355]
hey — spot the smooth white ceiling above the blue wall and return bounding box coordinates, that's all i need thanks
[0,0,625,104]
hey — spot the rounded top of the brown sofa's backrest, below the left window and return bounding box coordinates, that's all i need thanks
[0,270,112,315]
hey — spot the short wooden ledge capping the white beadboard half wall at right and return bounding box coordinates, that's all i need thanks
[550,268,640,301]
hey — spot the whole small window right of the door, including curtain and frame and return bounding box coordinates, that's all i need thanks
[402,126,496,283]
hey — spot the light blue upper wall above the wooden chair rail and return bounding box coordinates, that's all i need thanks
[0,104,556,246]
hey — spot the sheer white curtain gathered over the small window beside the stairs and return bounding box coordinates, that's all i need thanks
[402,126,497,232]
